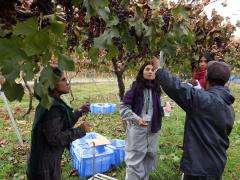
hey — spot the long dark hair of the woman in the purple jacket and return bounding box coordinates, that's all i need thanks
[132,62,161,93]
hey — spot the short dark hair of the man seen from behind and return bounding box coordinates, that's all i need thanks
[207,61,231,86]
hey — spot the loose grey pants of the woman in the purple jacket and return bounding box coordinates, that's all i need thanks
[125,121,158,180]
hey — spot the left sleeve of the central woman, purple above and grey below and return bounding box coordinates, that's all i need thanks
[119,89,142,121]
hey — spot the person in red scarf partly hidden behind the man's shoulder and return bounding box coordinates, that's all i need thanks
[192,52,214,89]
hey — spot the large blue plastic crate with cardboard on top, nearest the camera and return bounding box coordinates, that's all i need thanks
[70,132,115,178]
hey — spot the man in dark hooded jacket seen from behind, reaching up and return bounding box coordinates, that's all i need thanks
[154,59,235,180]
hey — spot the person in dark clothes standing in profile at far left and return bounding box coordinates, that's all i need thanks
[27,68,89,180]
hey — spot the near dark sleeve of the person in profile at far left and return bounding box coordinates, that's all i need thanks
[41,108,86,146]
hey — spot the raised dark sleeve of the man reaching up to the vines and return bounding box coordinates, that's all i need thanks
[156,68,195,112]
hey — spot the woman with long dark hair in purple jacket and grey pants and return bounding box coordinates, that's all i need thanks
[120,62,163,180]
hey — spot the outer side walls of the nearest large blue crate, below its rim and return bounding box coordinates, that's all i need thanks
[72,146,114,178]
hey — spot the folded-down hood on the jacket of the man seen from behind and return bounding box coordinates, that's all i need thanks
[208,86,235,105]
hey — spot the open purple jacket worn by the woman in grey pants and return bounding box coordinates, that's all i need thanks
[122,88,163,133]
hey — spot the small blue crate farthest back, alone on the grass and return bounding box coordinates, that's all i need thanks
[90,103,116,114]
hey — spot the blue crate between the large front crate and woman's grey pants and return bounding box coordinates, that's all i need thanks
[107,139,125,166]
